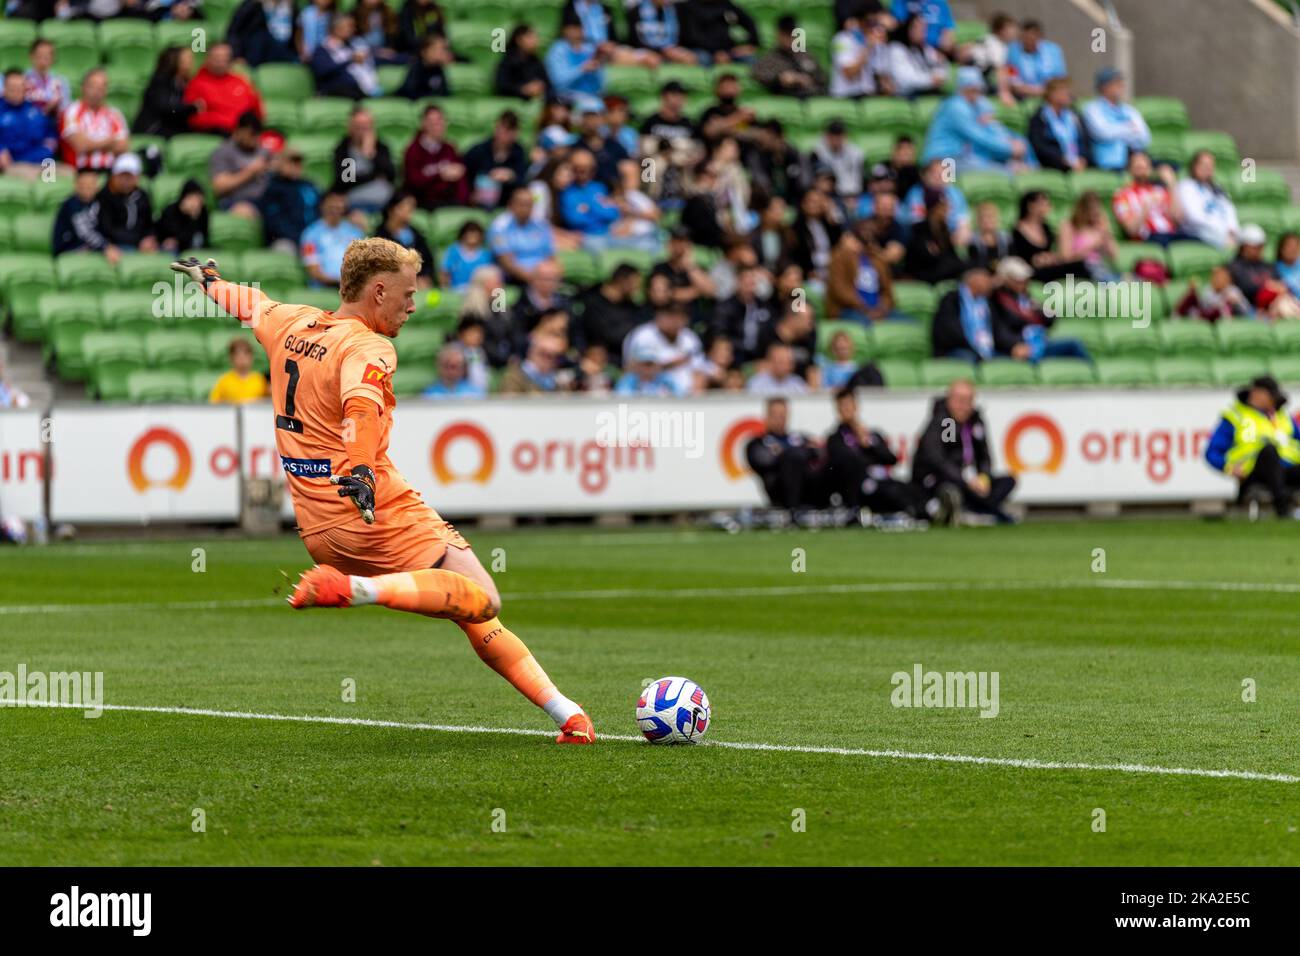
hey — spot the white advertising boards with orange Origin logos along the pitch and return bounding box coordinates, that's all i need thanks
[0,389,1235,523]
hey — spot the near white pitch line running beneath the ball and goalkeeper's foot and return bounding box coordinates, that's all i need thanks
[0,701,1300,783]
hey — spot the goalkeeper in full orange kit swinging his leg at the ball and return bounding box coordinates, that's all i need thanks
[172,239,595,744]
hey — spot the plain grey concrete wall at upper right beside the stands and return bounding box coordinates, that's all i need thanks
[957,0,1300,163]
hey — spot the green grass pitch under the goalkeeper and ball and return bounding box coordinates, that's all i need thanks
[0,520,1300,865]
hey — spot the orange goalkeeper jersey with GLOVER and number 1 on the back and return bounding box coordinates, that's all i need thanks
[208,282,429,535]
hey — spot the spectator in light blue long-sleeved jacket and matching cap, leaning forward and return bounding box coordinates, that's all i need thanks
[922,66,1036,172]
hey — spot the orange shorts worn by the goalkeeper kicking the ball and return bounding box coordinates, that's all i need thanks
[303,509,469,575]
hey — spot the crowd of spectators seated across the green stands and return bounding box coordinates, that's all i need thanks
[0,0,1300,397]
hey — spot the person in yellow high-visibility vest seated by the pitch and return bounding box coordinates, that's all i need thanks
[1205,375,1300,516]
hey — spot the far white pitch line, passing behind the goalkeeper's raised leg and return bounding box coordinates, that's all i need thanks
[12,579,1300,617]
